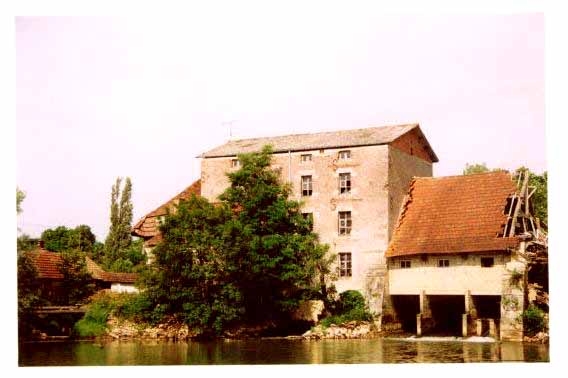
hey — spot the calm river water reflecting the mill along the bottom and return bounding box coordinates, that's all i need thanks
[18,338,549,366]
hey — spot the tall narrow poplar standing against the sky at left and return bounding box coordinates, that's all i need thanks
[101,177,138,272]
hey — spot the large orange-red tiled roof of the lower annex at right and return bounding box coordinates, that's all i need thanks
[386,171,518,257]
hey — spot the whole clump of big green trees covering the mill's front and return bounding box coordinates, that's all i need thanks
[145,147,336,333]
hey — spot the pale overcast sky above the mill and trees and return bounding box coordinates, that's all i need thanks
[15,12,547,241]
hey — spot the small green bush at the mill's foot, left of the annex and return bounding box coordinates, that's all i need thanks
[320,290,373,327]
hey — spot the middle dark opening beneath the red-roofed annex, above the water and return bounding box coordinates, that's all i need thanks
[428,295,465,336]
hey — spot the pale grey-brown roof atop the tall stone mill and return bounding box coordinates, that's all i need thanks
[199,123,426,158]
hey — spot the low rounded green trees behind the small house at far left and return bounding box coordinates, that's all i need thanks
[41,225,95,252]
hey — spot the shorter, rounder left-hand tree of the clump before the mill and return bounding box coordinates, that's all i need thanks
[143,196,241,333]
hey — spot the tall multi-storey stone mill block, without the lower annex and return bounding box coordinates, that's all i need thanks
[133,124,438,313]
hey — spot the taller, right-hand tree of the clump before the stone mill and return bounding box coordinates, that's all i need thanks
[220,147,327,320]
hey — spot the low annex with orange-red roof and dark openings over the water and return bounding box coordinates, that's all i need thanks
[383,171,539,340]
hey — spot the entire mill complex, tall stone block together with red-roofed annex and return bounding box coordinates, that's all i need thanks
[132,124,542,340]
